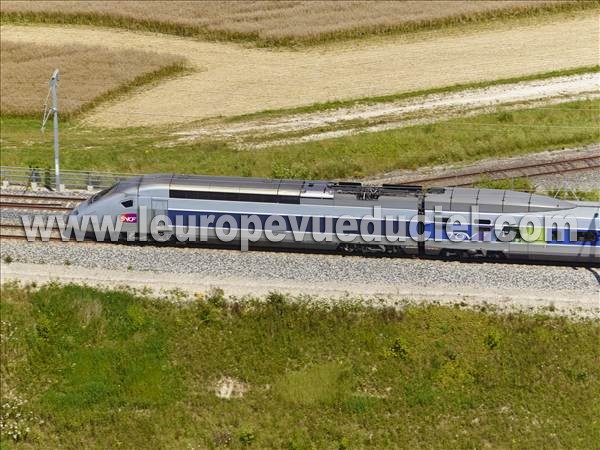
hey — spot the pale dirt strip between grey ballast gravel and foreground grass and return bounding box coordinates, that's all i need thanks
[0,263,600,317]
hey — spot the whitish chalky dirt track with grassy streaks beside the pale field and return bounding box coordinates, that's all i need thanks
[169,73,600,149]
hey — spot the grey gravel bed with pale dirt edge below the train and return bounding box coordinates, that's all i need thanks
[0,241,600,317]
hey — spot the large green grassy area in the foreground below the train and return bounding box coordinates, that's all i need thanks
[0,284,600,449]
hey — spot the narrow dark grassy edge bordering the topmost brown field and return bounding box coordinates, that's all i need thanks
[0,0,599,47]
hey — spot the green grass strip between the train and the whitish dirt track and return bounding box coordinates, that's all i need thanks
[0,100,600,179]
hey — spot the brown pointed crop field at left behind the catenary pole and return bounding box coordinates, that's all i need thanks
[0,39,183,115]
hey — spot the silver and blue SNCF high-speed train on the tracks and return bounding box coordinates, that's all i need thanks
[71,174,600,264]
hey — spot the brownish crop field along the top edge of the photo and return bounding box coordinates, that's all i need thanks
[0,1,598,46]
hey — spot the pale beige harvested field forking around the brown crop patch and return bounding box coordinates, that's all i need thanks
[1,13,600,126]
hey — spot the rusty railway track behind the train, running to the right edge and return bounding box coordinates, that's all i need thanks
[394,155,600,186]
